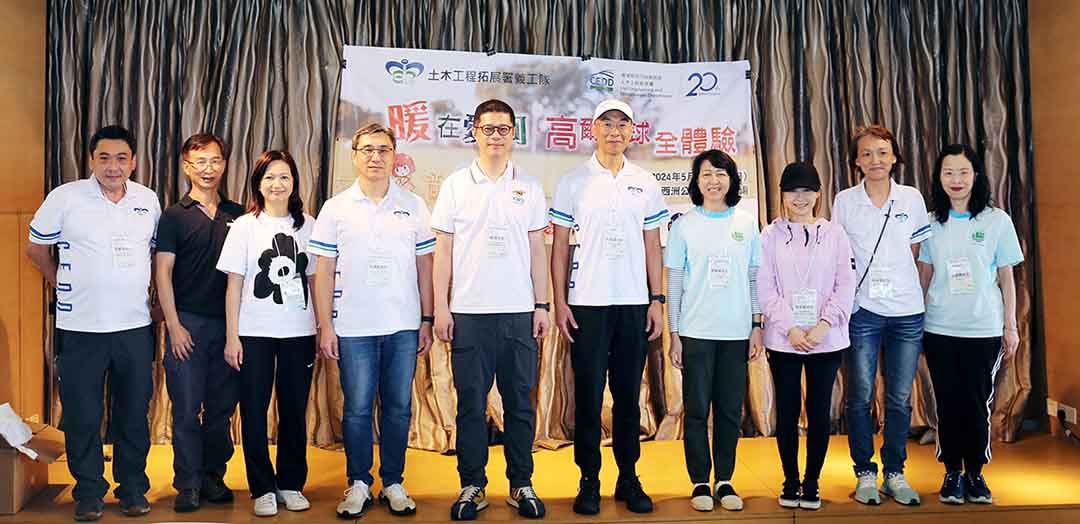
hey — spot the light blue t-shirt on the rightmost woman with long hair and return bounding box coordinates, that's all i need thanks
[919,207,1024,338]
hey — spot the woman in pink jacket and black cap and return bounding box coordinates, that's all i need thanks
[757,162,855,510]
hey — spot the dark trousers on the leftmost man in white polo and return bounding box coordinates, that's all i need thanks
[56,326,153,501]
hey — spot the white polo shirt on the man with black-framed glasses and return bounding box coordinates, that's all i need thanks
[431,161,548,313]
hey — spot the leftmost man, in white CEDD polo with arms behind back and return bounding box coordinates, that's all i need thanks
[26,125,161,521]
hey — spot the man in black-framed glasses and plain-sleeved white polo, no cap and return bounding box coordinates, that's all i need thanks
[432,99,551,521]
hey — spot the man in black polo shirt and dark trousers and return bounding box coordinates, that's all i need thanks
[154,133,244,512]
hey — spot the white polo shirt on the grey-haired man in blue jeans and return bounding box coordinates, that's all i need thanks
[308,183,435,337]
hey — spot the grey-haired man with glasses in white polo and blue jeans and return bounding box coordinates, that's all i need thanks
[308,123,435,519]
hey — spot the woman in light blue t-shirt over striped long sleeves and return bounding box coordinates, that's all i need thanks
[664,149,764,511]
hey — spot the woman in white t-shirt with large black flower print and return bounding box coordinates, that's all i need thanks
[217,151,315,516]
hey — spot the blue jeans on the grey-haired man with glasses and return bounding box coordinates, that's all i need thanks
[338,330,419,486]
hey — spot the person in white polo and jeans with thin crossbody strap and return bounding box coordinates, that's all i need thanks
[833,125,930,506]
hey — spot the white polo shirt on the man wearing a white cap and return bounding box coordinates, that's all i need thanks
[551,153,667,306]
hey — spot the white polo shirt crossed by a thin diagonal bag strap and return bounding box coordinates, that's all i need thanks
[833,178,932,317]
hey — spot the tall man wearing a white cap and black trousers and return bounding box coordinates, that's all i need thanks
[551,99,667,514]
